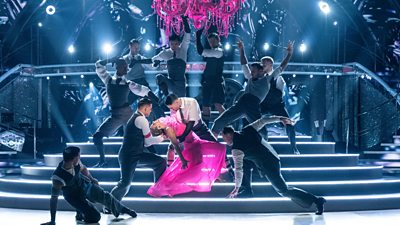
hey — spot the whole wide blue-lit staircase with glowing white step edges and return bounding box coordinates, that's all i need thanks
[0,137,400,213]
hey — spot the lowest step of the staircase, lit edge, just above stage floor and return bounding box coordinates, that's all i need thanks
[0,192,400,213]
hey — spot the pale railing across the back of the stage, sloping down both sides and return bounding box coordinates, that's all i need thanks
[0,62,400,155]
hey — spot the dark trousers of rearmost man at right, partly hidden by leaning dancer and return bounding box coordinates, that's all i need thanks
[261,102,297,149]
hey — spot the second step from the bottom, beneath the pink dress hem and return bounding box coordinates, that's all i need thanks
[0,177,400,198]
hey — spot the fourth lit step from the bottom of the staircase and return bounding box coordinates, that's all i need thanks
[44,154,359,167]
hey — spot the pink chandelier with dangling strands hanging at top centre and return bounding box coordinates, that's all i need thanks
[152,0,244,36]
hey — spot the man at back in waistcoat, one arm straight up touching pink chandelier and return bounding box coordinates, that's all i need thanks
[130,16,190,97]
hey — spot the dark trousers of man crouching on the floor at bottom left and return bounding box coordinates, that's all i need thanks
[63,184,125,223]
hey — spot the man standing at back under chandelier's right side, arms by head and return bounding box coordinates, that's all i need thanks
[196,29,225,125]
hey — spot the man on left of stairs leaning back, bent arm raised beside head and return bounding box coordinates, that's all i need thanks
[93,58,162,167]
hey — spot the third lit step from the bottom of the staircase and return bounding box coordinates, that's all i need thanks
[21,166,382,182]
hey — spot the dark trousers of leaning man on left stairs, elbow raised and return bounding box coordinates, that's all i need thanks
[93,106,133,162]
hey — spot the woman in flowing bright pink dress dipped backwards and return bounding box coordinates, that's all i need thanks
[147,117,226,197]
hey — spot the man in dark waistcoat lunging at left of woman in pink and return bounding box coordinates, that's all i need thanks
[111,98,167,200]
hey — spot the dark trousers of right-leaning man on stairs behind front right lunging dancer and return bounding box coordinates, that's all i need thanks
[211,93,268,136]
